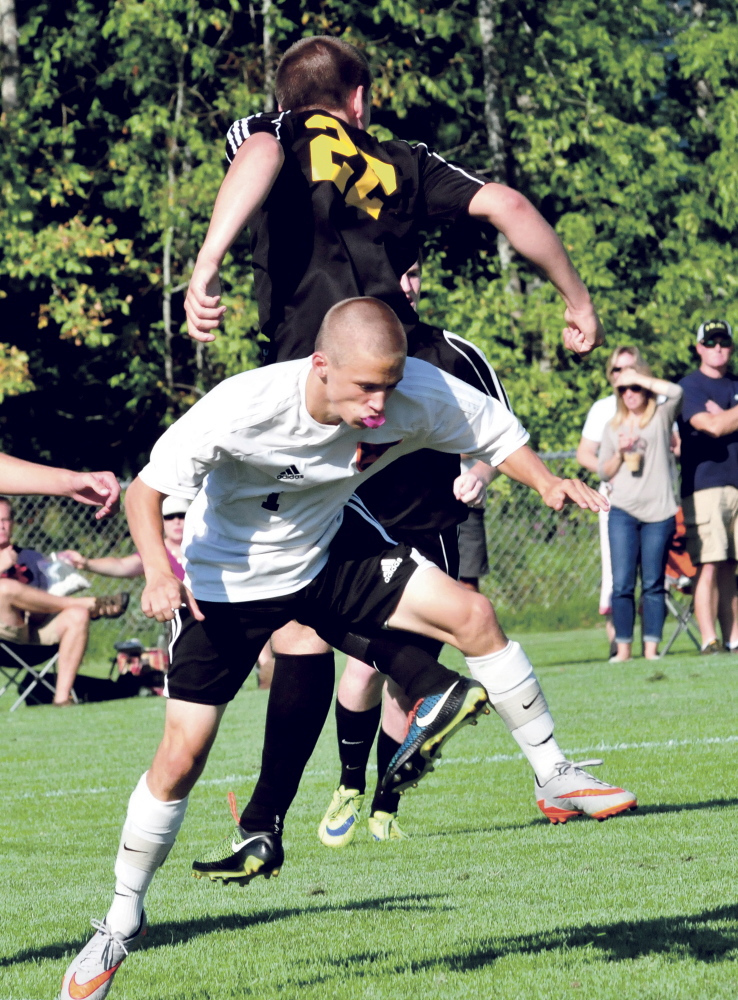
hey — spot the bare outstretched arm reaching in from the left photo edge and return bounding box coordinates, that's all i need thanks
[0,455,120,520]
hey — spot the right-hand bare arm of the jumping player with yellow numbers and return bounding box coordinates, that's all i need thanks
[469,184,605,354]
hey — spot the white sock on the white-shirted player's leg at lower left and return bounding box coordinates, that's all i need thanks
[105,772,187,937]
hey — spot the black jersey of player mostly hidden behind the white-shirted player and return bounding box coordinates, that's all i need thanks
[357,323,512,544]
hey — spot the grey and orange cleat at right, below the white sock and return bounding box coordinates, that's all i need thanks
[535,760,638,823]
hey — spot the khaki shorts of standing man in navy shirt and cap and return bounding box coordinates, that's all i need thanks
[682,486,738,563]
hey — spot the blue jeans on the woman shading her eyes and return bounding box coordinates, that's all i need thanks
[608,507,675,642]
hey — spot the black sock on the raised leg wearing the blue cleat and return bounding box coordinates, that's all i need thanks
[361,631,459,702]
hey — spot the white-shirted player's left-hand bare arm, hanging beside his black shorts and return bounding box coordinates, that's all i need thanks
[126,477,205,622]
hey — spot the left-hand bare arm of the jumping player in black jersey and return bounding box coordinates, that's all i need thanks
[185,133,284,343]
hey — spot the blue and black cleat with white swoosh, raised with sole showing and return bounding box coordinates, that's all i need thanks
[382,677,489,792]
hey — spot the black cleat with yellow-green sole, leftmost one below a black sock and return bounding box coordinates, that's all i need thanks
[192,792,284,885]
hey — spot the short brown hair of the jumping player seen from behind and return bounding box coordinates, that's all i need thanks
[274,35,372,111]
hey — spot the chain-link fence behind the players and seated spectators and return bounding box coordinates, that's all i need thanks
[7,452,600,656]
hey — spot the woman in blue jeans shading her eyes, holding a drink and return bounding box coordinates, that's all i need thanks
[599,363,682,663]
